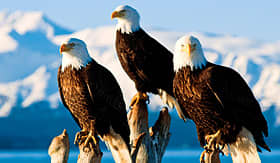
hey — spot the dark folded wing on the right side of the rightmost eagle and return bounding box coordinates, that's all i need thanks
[207,66,269,150]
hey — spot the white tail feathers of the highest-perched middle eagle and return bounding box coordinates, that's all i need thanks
[158,89,186,122]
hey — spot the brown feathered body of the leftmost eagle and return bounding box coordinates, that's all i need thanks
[58,60,130,147]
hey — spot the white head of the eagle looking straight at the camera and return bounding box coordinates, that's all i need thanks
[173,36,207,71]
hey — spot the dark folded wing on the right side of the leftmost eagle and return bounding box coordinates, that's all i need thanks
[84,61,130,146]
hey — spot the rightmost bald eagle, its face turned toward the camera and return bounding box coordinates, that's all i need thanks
[173,36,270,163]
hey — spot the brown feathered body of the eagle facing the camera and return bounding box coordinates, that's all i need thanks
[173,62,270,150]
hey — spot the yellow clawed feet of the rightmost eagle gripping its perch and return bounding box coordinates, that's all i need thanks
[204,130,224,151]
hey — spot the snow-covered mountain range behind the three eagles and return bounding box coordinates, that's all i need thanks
[0,11,280,149]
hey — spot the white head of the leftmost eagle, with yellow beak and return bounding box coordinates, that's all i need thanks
[60,38,92,71]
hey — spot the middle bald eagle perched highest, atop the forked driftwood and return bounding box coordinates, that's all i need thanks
[111,5,184,119]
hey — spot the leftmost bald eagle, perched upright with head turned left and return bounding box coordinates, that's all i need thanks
[57,38,130,148]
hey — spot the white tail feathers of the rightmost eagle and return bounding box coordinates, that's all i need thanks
[229,127,261,163]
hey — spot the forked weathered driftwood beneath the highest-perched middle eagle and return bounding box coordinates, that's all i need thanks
[128,100,171,163]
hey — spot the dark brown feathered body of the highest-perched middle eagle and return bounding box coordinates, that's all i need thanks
[116,28,174,95]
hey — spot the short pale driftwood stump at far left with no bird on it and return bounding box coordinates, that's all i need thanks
[48,129,69,163]
